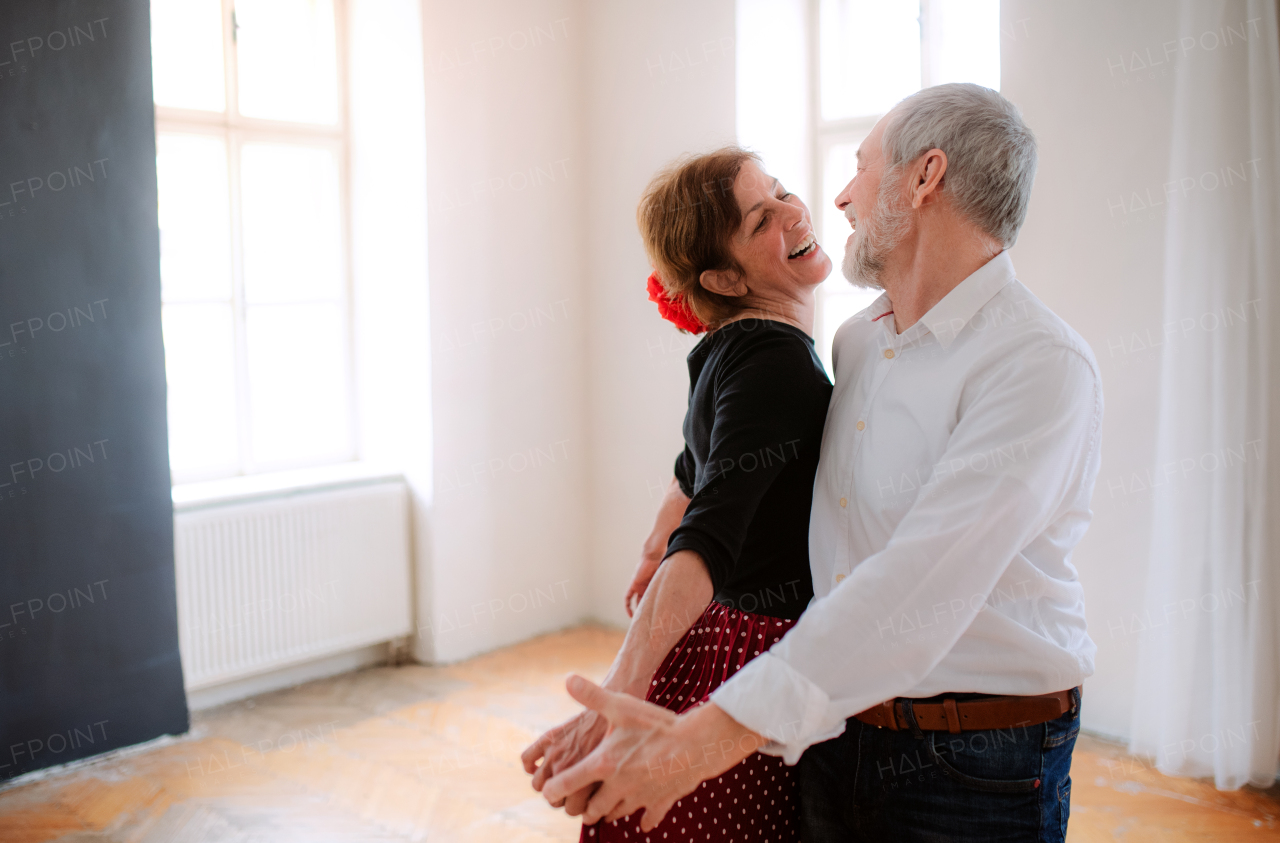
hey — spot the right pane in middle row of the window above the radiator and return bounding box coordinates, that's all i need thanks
[241,143,343,303]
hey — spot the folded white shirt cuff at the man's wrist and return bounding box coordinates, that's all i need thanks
[710,652,845,764]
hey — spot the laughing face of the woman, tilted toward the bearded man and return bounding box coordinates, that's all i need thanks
[730,160,831,298]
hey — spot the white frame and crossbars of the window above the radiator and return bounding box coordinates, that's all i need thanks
[155,0,360,482]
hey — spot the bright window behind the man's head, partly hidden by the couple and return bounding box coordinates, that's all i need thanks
[808,0,1000,371]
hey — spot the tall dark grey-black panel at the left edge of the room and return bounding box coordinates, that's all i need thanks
[0,0,188,779]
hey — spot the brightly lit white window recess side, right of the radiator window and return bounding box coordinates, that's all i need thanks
[347,0,433,660]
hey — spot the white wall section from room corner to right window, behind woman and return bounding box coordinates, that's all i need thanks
[585,0,735,634]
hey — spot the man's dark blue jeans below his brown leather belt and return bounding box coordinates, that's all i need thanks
[800,692,1080,843]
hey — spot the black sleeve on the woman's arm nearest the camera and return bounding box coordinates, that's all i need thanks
[667,336,829,590]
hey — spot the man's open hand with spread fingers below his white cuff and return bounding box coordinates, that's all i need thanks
[543,675,763,831]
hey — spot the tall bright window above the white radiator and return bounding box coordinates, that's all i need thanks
[151,0,355,482]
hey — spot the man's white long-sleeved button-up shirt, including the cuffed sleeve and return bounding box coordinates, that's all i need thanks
[712,253,1102,764]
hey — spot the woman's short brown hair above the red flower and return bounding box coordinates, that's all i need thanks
[636,146,760,329]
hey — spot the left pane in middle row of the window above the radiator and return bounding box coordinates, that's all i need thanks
[156,134,232,302]
